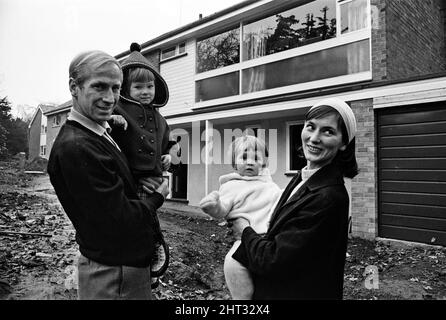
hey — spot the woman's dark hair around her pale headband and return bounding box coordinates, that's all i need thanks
[305,105,359,179]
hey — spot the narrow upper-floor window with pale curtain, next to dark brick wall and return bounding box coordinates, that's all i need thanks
[340,0,368,34]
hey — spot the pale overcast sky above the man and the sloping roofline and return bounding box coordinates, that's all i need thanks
[0,0,243,116]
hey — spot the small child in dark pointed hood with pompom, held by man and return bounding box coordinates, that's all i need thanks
[111,43,171,287]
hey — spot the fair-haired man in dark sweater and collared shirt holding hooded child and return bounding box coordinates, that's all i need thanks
[48,51,168,300]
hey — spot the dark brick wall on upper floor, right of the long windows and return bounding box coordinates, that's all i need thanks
[386,0,446,80]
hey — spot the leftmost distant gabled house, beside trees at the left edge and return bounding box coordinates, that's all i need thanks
[28,104,56,161]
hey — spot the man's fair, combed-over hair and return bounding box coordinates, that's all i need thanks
[68,50,122,85]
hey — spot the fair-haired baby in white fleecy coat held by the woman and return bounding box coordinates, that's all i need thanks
[200,135,281,300]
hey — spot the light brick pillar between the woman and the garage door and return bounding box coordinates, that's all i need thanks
[351,99,378,239]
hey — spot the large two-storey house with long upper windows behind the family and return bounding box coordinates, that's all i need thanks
[116,0,446,245]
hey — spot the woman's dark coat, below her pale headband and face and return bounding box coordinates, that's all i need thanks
[233,164,349,299]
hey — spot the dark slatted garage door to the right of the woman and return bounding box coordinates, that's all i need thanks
[377,102,446,246]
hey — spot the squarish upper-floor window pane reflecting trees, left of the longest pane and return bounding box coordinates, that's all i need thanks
[197,27,240,73]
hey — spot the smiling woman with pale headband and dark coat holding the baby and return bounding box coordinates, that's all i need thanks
[232,98,358,299]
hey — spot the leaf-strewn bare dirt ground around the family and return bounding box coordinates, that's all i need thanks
[0,162,446,300]
